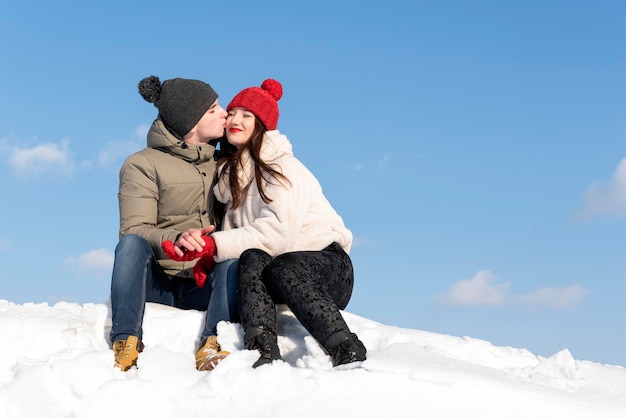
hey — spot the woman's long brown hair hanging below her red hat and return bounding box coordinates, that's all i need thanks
[217,116,291,209]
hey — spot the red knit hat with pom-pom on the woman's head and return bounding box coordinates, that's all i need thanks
[226,78,283,131]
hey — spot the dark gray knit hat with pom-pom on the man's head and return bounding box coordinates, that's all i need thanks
[138,75,217,139]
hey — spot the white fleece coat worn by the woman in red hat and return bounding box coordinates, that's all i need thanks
[212,130,352,262]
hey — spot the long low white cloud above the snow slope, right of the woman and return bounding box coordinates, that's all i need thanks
[439,270,589,309]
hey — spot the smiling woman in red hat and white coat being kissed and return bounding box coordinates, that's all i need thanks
[200,79,366,367]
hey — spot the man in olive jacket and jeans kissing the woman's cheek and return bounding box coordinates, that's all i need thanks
[110,76,237,371]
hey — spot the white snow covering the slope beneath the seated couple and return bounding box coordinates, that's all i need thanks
[0,300,626,418]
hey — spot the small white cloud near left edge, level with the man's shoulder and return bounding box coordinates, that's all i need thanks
[8,139,75,178]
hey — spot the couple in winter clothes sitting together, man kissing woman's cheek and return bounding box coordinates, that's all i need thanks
[105,76,366,371]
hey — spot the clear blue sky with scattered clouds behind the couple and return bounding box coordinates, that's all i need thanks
[0,0,626,366]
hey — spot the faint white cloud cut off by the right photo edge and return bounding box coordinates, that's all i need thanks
[574,158,626,220]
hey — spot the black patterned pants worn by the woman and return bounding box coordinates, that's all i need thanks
[237,243,354,345]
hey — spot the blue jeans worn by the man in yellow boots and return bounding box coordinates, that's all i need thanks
[110,234,239,342]
